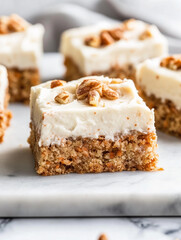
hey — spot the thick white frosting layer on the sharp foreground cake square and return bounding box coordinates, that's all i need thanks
[30,76,155,146]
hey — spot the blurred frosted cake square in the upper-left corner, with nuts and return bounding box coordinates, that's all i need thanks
[0,14,44,103]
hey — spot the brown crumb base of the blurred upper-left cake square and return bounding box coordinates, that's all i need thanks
[7,68,40,104]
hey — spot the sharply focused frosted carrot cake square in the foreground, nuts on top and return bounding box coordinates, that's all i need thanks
[29,76,157,176]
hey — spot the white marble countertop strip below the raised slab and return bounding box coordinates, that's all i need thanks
[0,218,181,240]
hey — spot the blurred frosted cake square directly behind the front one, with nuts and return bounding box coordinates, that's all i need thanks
[60,19,167,80]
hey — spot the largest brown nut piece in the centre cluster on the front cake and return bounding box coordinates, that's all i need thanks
[76,79,102,100]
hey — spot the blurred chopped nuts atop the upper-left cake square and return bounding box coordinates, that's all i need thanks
[0,14,29,34]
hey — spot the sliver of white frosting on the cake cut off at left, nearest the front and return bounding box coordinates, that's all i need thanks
[0,65,8,111]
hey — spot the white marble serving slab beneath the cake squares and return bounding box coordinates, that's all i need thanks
[0,55,181,217]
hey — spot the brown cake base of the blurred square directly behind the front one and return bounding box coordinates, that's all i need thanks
[64,57,135,81]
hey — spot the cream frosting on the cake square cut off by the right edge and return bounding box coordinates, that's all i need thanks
[136,58,181,109]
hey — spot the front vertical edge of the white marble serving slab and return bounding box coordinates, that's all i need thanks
[0,194,181,217]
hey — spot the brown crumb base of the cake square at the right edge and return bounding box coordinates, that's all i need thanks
[139,91,181,137]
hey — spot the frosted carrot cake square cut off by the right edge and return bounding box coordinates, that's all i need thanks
[136,55,181,137]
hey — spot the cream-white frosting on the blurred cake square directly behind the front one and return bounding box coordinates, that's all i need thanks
[60,20,168,75]
